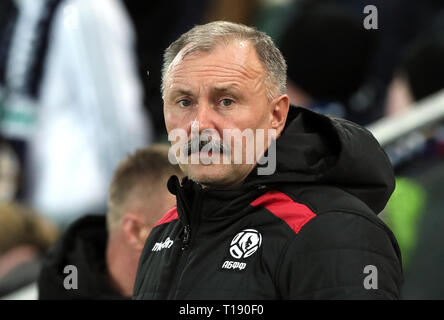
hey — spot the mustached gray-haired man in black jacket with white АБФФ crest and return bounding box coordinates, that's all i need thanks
[133,22,402,300]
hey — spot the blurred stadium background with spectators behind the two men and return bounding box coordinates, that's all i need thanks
[0,0,444,299]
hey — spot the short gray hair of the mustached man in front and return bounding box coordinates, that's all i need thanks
[161,21,287,99]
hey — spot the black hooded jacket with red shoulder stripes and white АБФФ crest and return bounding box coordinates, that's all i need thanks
[133,107,402,300]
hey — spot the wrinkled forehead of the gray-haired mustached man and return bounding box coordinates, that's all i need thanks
[165,39,264,91]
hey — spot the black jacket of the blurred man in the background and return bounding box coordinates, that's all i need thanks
[38,215,123,300]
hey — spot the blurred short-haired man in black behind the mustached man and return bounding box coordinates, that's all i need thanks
[38,145,180,299]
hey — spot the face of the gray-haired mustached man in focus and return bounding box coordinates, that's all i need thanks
[164,40,288,187]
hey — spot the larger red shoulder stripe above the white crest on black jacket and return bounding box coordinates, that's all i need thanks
[251,191,316,233]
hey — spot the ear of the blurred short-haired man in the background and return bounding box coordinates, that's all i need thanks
[121,212,150,251]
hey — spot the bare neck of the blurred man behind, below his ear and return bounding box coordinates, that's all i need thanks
[106,235,138,297]
